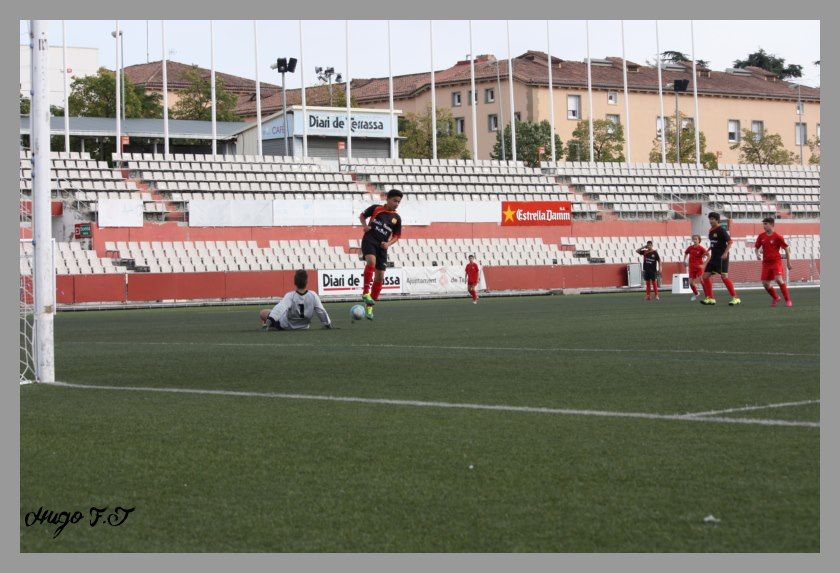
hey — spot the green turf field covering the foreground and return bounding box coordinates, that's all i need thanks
[20,289,820,552]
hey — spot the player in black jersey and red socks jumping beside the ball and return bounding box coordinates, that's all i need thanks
[359,189,402,320]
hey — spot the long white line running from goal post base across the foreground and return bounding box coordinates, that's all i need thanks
[43,382,820,428]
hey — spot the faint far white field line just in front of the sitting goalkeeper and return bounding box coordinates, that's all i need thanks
[60,340,819,357]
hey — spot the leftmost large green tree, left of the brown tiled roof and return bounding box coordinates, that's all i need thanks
[69,68,163,118]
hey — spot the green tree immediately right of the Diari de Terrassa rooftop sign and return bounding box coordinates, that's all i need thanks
[398,106,470,159]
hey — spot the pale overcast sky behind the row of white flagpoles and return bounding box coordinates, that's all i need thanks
[20,20,820,87]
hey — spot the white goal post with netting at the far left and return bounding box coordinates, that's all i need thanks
[19,20,55,383]
